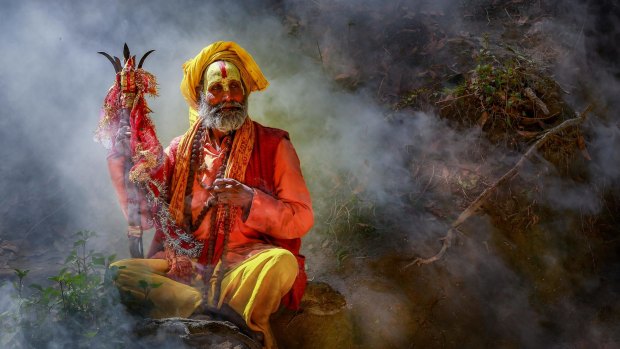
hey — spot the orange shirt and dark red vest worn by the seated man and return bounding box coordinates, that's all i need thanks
[108,122,313,302]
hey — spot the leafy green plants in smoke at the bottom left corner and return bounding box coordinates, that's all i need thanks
[0,231,130,347]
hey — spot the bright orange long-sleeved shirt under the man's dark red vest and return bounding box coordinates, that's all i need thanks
[161,122,314,256]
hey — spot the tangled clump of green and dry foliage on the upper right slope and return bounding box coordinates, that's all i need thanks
[438,38,571,150]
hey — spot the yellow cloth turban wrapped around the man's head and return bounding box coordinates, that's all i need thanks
[181,41,269,125]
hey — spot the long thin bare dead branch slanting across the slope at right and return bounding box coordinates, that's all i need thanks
[404,105,592,268]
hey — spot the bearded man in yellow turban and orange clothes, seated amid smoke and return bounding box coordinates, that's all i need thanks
[108,42,313,348]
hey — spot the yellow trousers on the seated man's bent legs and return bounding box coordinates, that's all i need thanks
[112,248,298,348]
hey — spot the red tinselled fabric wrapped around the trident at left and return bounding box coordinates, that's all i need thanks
[95,65,163,229]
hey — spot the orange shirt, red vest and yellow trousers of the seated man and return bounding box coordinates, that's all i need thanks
[108,123,314,348]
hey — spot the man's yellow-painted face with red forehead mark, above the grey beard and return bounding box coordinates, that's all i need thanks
[202,61,245,105]
